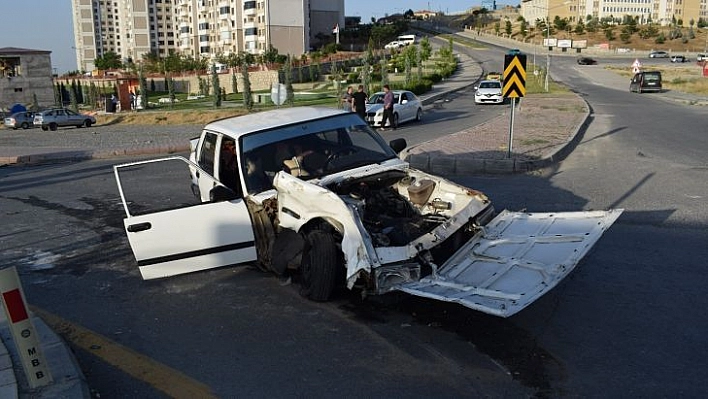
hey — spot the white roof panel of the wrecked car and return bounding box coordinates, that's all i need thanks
[204,107,350,139]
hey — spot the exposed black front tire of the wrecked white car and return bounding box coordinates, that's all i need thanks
[300,229,340,302]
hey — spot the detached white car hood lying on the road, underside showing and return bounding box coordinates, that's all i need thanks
[397,209,622,317]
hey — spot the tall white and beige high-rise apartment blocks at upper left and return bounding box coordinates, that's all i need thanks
[72,0,344,71]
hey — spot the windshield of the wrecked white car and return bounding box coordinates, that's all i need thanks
[240,113,397,194]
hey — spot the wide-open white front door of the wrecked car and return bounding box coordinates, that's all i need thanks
[113,156,257,280]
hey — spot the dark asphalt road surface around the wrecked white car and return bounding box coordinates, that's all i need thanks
[0,47,708,398]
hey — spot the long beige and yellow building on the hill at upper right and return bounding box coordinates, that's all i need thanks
[520,0,708,26]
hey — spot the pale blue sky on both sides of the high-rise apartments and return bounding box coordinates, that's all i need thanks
[0,0,492,74]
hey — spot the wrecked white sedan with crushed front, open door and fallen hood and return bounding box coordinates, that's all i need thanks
[114,107,622,317]
